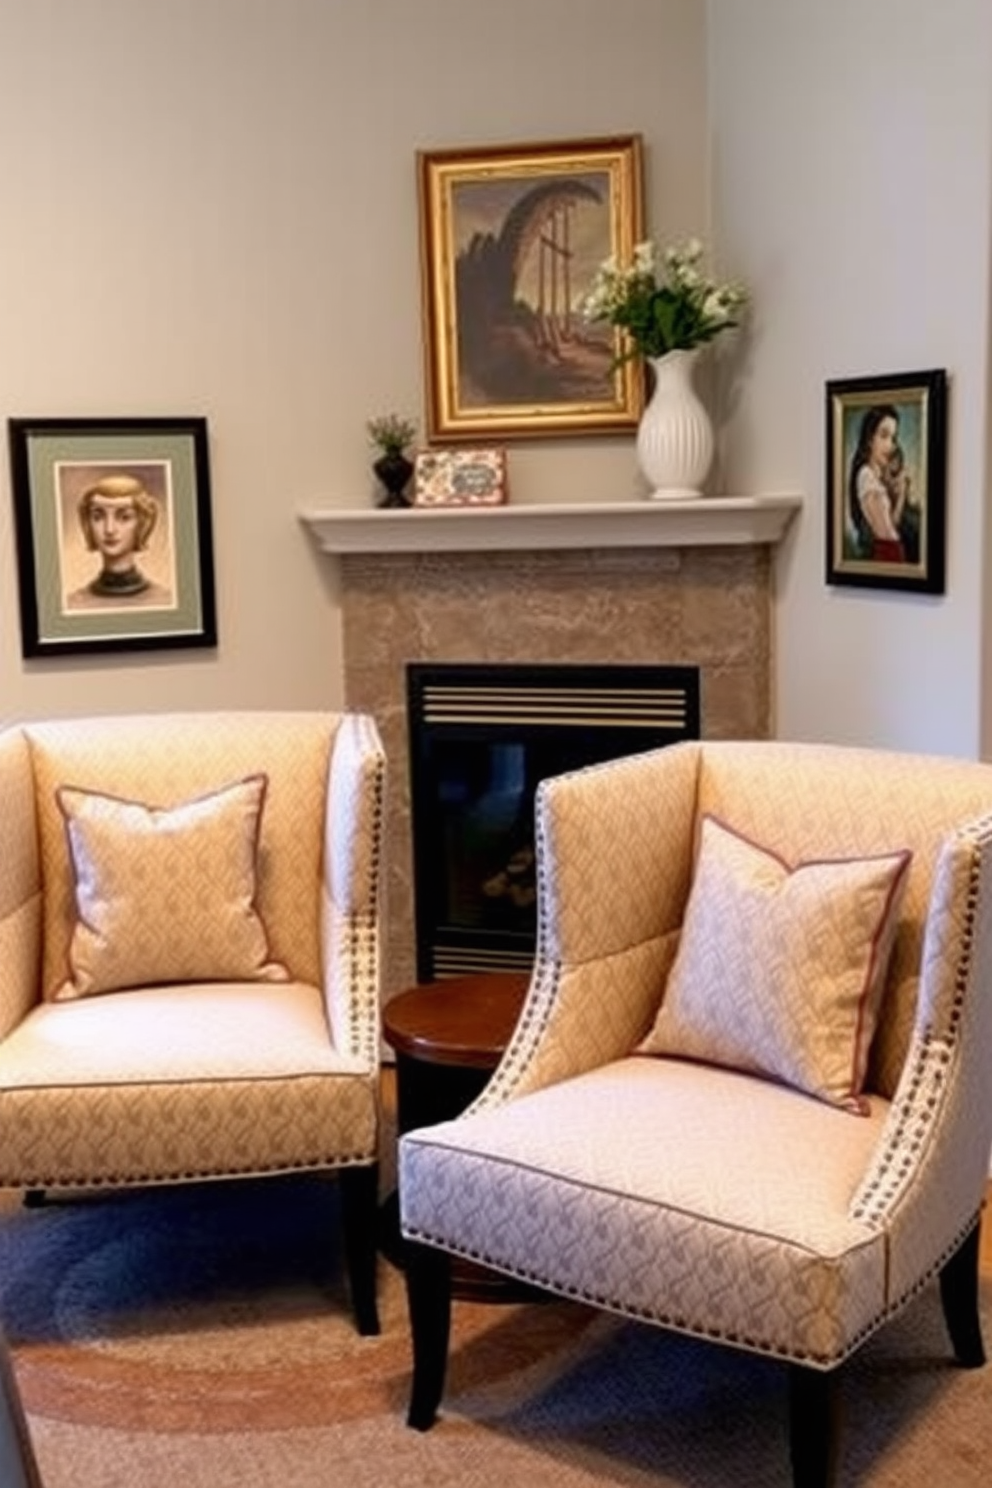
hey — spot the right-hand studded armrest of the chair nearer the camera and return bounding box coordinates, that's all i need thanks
[852,817,992,1303]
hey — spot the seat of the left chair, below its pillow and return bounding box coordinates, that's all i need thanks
[0,982,378,1187]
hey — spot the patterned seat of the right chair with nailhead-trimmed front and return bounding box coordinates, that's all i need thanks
[400,1058,888,1363]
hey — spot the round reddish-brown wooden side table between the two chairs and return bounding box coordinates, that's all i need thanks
[382,972,531,1301]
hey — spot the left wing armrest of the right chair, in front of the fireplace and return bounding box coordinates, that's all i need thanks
[482,744,700,1104]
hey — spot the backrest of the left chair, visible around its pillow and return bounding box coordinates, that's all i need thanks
[22,713,341,995]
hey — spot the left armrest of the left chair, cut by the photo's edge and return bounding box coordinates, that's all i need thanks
[0,729,42,1039]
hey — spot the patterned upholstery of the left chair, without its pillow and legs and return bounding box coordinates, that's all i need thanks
[0,713,384,1189]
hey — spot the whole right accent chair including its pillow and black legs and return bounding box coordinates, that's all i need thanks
[399,743,992,1488]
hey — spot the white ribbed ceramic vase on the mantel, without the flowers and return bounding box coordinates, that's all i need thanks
[637,347,712,501]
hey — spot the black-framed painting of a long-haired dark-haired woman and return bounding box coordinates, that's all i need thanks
[825,368,947,594]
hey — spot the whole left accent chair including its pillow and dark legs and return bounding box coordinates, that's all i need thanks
[0,711,384,1333]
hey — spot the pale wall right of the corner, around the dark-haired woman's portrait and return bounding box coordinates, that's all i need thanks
[708,0,992,757]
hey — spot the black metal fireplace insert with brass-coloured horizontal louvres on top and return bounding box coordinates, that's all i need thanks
[408,664,700,982]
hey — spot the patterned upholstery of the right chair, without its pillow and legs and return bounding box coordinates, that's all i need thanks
[400,743,992,1369]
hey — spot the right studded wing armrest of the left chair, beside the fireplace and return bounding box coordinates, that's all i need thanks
[321,713,385,1070]
